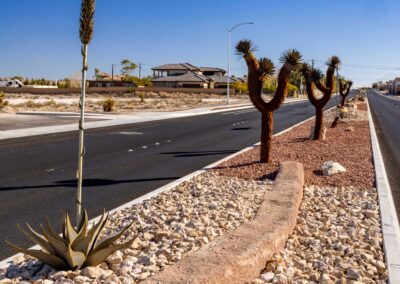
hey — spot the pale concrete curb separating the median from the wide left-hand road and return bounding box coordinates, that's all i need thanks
[0,100,324,269]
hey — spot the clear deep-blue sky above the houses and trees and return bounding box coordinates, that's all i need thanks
[0,0,400,85]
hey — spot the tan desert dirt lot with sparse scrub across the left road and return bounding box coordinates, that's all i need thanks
[0,92,250,113]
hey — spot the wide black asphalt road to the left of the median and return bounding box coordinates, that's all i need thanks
[0,97,339,259]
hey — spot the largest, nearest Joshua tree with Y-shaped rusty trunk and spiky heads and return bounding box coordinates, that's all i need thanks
[236,40,301,163]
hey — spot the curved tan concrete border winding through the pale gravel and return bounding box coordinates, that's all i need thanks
[143,162,304,284]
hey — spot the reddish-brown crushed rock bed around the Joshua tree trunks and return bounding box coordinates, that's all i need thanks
[212,111,375,188]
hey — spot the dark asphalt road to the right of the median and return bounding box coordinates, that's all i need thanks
[368,90,400,216]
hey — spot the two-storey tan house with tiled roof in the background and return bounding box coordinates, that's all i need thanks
[152,63,239,88]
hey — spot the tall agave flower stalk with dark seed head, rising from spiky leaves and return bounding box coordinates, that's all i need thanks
[76,0,96,227]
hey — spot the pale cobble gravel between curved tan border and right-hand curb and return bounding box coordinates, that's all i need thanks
[253,186,388,284]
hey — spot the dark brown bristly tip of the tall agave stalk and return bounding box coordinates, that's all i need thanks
[79,0,96,45]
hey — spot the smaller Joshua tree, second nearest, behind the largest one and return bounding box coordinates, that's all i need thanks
[301,56,340,140]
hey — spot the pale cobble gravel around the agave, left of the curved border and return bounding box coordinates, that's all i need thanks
[0,172,272,284]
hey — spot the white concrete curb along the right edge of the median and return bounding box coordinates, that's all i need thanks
[367,100,400,283]
